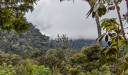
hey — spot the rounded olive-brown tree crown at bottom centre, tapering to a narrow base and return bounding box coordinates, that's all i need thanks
[39,49,65,74]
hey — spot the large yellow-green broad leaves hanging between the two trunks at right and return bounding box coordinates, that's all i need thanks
[98,18,126,48]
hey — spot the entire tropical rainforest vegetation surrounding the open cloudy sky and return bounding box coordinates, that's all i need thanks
[0,0,128,75]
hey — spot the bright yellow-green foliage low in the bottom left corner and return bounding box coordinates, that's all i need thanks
[0,59,51,75]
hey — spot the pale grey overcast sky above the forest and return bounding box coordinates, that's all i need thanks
[26,0,127,39]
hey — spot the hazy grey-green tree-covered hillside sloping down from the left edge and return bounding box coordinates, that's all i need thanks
[0,26,49,54]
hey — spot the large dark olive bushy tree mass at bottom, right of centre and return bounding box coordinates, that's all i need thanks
[56,45,111,75]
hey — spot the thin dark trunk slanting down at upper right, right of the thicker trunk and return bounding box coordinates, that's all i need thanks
[114,0,127,41]
